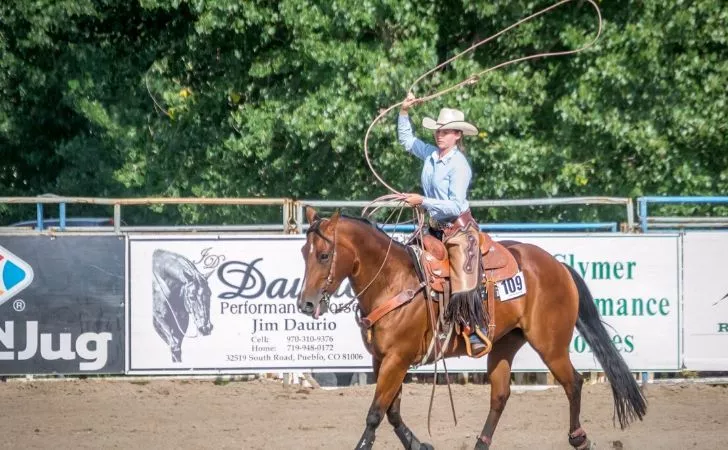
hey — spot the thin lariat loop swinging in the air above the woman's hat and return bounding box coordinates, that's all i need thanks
[364,0,602,194]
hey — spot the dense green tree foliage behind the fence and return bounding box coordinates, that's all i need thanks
[0,0,728,222]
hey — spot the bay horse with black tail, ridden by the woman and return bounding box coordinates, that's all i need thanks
[298,207,647,450]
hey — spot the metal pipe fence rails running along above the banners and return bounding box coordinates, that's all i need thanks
[9,195,728,233]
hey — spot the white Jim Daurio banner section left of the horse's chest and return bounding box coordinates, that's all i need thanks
[128,235,371,373]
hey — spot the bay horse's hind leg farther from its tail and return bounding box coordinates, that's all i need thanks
[475,330,526,450]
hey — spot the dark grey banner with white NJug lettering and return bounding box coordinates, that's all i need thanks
[0,236,125,375]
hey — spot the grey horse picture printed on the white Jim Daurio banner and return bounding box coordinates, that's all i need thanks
[152,249,213,362]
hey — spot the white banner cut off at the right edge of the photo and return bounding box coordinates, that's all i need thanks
[683,231,728,371]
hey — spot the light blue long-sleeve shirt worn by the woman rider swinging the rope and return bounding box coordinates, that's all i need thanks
[397,115,473,222]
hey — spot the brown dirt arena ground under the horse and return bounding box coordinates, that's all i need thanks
[0,380,728,450]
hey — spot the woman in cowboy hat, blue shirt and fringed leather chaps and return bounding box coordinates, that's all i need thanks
[397,93,487,356]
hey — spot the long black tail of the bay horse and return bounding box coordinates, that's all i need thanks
[564,264,647,429]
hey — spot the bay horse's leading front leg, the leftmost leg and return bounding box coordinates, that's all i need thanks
[356,355,412,450]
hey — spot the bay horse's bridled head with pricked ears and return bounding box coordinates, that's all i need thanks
[298,207,354,319]
